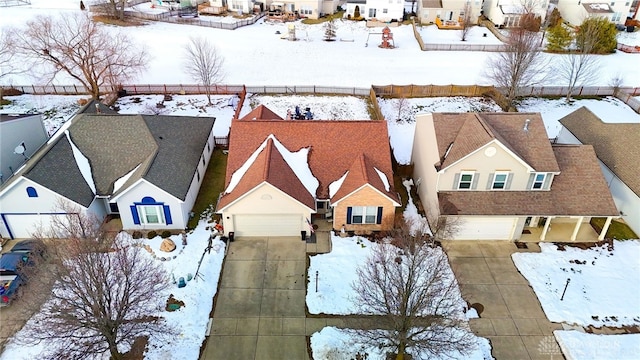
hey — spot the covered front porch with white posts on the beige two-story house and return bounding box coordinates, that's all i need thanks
[519,216,613,242]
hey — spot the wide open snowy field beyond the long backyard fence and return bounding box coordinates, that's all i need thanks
[0,0,640,87]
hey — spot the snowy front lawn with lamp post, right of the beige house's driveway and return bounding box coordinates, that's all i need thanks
[512,240,640,327]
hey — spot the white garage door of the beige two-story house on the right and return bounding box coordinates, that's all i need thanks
[453,217,518,240]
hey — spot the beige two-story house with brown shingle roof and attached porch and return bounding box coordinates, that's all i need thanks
[412,113,618,241]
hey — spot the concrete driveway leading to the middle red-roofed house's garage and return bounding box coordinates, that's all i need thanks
[201,237,315,360]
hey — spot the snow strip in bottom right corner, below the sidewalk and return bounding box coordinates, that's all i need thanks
[553,330,640,360]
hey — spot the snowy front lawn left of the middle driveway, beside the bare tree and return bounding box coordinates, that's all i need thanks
[0,221,225,360]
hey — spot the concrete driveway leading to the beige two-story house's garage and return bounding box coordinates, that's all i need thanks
[442,241,562,360]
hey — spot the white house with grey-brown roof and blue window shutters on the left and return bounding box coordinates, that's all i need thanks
[0,104,214,238]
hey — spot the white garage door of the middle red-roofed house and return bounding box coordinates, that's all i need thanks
[233,214,306,237]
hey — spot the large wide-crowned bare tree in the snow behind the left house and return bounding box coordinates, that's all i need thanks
[9,12,148,99]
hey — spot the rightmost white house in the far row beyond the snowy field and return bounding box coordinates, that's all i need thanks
[558,0,631,26]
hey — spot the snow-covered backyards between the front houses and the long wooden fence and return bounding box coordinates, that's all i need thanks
[0,94,640,164]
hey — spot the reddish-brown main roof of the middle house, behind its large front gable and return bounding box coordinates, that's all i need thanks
[225,108,398,201]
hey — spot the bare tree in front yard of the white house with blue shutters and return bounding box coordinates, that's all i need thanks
[17,205,173,359]
